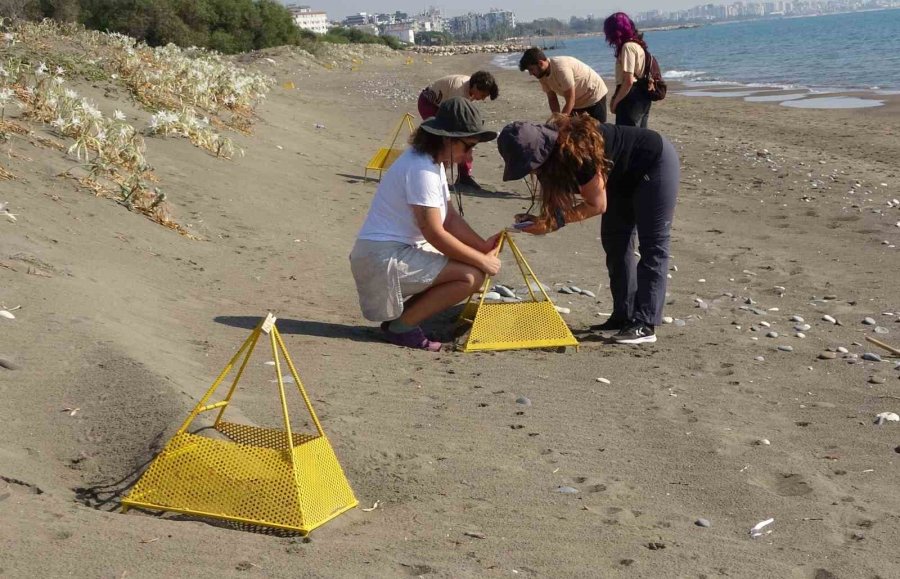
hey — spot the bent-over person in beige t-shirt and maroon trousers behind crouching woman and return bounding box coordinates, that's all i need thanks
[418,70,500,191]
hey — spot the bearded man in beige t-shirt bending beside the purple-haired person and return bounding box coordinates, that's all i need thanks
[519,47,607,123]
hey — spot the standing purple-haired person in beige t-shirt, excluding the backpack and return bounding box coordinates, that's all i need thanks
[603,12,651,128]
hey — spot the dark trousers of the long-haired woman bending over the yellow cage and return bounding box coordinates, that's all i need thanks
[600,138,680,326]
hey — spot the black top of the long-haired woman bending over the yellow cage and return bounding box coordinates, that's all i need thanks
[576,123,663,195]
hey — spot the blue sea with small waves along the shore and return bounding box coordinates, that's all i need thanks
[494,9,900,108]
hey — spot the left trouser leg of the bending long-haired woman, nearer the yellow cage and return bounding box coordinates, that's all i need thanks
[600,194,637,322]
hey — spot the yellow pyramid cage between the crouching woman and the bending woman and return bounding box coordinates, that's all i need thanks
[459,231,578,352]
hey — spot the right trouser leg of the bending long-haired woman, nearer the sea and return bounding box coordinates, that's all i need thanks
[633,139,680,326]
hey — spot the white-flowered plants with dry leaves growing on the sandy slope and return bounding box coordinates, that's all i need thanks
[0,19,273,237]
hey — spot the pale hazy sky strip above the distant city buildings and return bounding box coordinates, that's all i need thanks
[281,0,704,21]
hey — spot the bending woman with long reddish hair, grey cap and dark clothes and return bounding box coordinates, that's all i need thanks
[497,115,679,344]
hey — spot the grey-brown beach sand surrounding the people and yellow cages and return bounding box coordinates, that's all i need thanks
[0,43,900,578]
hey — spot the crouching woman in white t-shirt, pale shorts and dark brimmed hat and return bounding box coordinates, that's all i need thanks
[350,97,500,352]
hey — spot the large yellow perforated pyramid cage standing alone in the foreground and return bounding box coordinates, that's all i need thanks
[122,314,358,535]
